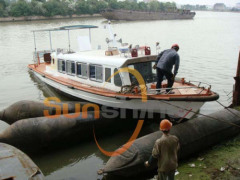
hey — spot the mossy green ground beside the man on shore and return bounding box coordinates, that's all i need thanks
[176,136,240,180]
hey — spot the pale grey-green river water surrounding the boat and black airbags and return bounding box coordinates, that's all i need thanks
[0,12,240,180]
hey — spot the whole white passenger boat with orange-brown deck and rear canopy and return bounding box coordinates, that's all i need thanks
[28,25,219,119]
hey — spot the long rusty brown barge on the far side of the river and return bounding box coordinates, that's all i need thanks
[101,9,196,21]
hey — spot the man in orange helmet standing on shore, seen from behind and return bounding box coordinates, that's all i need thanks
[145,119,180,180]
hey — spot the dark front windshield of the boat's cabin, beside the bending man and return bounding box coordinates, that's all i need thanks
[128,61,157,84]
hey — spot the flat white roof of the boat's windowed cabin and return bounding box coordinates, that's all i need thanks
[57,50,156,67]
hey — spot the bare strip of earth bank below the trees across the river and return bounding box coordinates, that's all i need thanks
[0,14,102,23]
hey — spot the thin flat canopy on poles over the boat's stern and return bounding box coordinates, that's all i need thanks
[32,25,98,32]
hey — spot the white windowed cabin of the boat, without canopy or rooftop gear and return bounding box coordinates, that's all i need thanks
[46,50,156,91]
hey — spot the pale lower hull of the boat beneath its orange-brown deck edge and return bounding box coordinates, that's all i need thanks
[31,71,204,119]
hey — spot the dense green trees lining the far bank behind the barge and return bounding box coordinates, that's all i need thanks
[0,0,177,17]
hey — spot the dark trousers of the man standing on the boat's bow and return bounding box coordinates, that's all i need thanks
[156,68,174,92]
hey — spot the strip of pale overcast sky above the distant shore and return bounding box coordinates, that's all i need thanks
[159,0,240,6]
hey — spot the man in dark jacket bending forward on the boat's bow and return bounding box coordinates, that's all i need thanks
[153,44,180,93]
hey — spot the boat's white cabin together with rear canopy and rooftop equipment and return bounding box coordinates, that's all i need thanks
[33,25,156,92]
